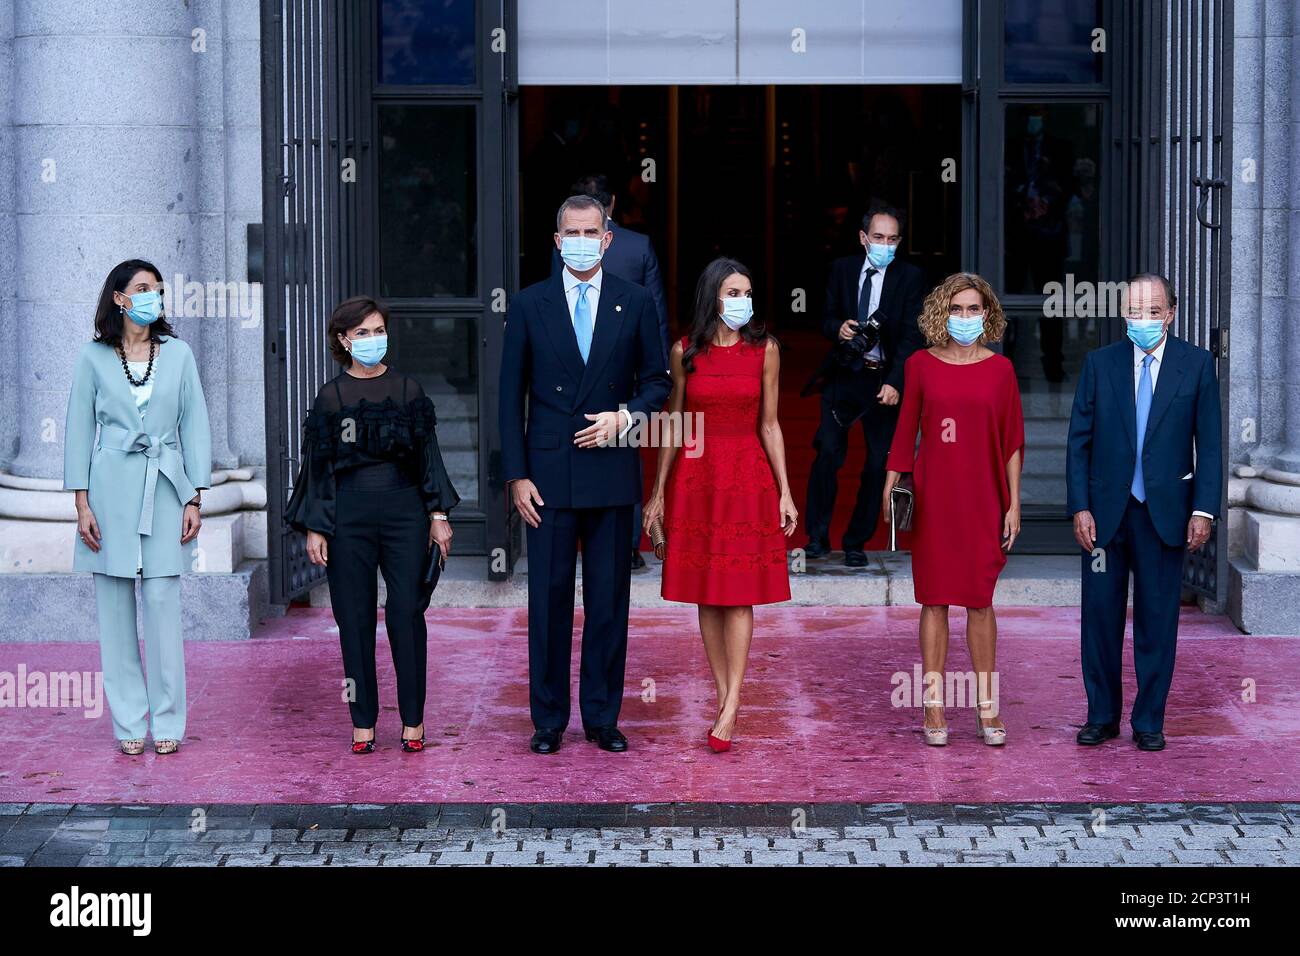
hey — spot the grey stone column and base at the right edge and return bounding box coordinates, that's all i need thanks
[1229,0,1300,633]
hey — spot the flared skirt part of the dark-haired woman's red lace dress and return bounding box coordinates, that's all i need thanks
[660,433,790,606]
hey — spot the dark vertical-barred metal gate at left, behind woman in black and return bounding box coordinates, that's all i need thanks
[261,0,363,604]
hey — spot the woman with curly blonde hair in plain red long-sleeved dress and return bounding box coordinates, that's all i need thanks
[881,272,1024,747]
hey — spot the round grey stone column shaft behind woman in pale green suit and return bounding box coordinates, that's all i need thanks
[10,0,199,479]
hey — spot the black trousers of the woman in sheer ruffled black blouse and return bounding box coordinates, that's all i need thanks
[326,484,429,730]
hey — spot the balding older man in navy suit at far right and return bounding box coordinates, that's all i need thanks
[1066,273,1223,750]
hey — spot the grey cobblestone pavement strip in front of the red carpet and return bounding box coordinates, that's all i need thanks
[0,804,1300,866]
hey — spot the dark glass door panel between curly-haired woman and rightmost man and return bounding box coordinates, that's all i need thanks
[965,0,1123,553]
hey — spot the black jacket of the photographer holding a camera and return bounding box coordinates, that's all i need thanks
[822,252,926,393]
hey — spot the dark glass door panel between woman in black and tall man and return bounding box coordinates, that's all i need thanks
[360,0,517,579]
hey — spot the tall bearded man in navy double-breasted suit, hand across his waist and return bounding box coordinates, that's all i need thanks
[501,196,672,753]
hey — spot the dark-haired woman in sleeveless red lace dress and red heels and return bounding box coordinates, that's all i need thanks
[644,259,798,752]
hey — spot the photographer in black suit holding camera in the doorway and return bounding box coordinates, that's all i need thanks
[803,204,926,567]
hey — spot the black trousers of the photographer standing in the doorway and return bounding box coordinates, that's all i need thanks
[805,369,898,551]
